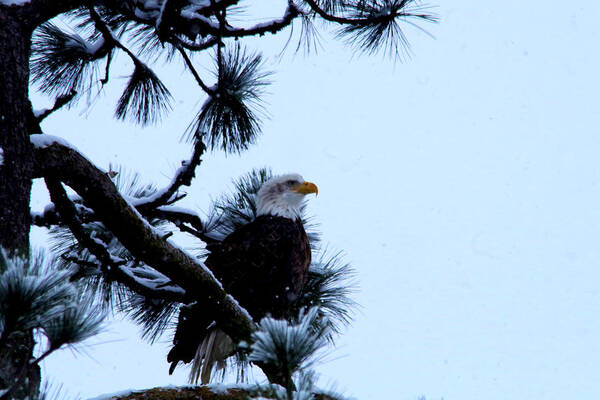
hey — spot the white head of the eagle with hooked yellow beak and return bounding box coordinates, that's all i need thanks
[256,174,319,219]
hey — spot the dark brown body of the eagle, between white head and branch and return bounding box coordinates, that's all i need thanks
[206,215,311,321]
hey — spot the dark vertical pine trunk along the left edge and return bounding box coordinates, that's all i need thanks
[0,6,40,399]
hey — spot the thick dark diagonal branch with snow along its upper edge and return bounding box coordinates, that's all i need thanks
[34,143,254,341]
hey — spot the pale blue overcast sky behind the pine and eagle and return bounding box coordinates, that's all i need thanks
[33,0,600,400]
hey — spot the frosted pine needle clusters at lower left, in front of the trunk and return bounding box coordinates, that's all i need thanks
[0,249,105,400]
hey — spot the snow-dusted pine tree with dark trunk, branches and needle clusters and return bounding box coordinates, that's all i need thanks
[0,0,436,399]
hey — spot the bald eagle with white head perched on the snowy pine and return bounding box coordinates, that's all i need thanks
[167,174,318,383]
